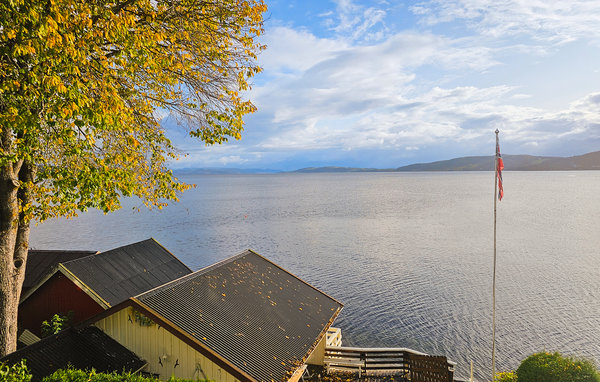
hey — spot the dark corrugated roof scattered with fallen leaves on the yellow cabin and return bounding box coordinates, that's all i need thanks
[136,250,342,381]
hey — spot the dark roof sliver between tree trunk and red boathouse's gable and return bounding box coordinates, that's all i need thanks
[21,249,97,294]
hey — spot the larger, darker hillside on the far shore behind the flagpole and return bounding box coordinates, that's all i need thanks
[396,151,600,171]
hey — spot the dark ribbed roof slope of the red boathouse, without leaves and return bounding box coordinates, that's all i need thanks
[62,239,192,305]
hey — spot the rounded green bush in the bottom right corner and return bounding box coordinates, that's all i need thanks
[517,352,600,382]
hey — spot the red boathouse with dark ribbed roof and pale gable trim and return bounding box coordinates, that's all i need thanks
[19,239,192,336]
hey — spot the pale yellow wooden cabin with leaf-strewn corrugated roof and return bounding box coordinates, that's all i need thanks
[87,250,342,382]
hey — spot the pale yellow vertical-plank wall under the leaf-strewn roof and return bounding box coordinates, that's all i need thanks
[95,307,240,382]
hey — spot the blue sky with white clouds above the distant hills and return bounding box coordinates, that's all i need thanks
[164,0,600,170]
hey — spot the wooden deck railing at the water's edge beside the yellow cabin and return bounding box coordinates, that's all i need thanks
[324,347,456,382]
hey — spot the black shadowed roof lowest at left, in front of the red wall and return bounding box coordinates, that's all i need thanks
[0,327,146,381]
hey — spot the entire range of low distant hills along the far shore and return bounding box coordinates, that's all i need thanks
[176,151,600,174]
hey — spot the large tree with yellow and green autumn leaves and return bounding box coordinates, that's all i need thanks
[0,0,266,356]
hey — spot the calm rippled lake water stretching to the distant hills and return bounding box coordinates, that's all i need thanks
[30,171,600,380]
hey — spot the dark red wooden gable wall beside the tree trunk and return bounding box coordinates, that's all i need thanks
[19,272,104,336]
